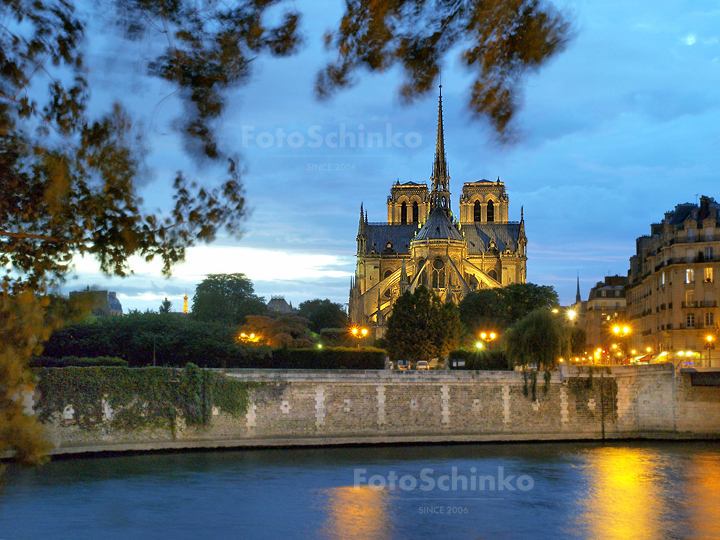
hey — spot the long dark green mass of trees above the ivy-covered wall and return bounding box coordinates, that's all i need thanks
[43,311,269,367]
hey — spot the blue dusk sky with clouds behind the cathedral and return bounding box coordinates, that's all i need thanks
[63,0,720,311]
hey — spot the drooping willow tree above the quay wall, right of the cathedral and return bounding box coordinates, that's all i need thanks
[505,309,569,370]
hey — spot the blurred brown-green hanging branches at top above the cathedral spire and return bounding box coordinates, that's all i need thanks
[315,0,570,134]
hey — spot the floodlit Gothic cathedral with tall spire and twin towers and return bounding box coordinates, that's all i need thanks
[349,86,527,337]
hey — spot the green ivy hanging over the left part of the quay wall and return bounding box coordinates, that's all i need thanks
[36,364,257,430]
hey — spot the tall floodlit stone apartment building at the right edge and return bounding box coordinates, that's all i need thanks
[627,196,720,353]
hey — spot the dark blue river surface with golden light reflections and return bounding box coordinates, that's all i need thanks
[0,442,720,540]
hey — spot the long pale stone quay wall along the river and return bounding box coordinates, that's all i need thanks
[35,364,720,454]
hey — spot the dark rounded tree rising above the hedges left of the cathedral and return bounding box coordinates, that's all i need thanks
[192,274,267,325]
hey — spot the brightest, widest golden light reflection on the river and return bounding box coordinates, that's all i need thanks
[580,448,666,540]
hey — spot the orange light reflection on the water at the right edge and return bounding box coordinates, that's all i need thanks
[686,454,720,540]
